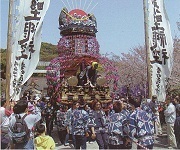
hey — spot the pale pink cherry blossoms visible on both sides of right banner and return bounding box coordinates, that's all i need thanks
[117,37,180,95]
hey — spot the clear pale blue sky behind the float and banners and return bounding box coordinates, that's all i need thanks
[0,0,180,55]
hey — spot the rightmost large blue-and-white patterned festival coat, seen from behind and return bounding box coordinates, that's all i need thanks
[129,108,154,146]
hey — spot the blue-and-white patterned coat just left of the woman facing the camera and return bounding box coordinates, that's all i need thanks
[71,109,89,135]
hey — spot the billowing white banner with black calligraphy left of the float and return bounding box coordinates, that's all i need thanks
[10,0,50,100]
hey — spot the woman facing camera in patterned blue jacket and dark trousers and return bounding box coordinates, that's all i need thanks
[89,100,108,149]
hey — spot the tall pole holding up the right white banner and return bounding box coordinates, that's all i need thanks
[143,0,152,98]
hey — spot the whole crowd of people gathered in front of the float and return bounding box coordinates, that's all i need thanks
[0,93,180,150]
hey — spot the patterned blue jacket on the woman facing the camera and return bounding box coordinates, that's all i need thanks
[88,110,108,133]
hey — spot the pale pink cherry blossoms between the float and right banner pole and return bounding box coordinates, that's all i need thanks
[115,46,147,95]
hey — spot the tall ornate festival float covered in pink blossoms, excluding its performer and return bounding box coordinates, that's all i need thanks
[46,8,119,104]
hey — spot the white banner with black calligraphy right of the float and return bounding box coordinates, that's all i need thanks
[148,0,173,101]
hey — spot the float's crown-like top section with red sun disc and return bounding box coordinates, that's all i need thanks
[59,8,97,36]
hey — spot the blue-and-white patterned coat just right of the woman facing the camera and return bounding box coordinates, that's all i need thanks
[108,113,129,145]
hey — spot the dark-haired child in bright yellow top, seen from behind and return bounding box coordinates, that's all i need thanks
[34,124,55,150]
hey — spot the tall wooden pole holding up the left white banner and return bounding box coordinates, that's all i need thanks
[6,0,14,106]
